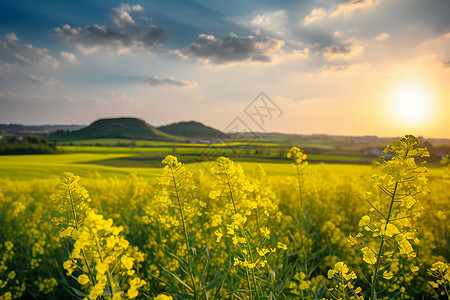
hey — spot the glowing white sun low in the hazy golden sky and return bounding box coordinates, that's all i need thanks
[391,85,433,125]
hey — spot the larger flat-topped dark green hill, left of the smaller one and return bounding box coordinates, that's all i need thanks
[49,118,179,141]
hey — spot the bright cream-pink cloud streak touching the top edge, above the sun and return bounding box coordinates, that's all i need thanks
[303,0,381,25]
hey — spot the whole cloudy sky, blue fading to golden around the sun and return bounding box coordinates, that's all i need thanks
[0,0,450,138]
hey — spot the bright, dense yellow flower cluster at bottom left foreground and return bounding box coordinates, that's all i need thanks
[63,212,145,299]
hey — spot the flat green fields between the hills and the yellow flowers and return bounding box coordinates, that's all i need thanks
[0,136,443,180]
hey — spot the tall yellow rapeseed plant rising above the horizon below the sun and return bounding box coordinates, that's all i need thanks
[348,135,429,299]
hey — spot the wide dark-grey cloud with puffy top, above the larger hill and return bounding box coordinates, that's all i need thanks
[55,4,167,53]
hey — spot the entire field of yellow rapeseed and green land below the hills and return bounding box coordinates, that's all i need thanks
[0,136,450,300]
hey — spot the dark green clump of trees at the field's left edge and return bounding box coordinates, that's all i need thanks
[0,135,61,155]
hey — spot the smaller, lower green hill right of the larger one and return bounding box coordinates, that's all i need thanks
[157,121,222,139]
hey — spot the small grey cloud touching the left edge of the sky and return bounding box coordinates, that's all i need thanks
[0,32,59,68]
